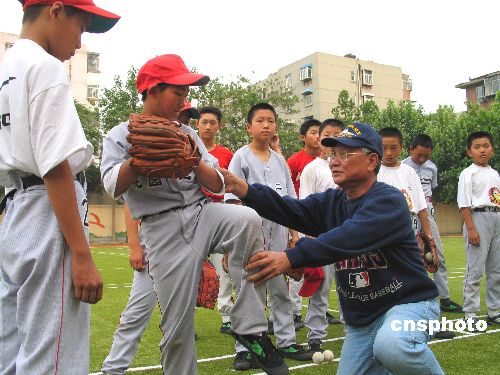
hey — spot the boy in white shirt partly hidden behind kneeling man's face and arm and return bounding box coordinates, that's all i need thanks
[299,120,344,353]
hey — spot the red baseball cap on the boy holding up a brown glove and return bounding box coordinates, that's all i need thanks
[136,55,210,93]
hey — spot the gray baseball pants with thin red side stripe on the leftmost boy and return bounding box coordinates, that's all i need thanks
[0,181,90,375]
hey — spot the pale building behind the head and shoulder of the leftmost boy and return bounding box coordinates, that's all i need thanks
[0,32,101,106]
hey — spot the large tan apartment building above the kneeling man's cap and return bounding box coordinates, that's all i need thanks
[259,52,412,123]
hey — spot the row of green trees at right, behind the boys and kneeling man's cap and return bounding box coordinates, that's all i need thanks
[332,90,500,203]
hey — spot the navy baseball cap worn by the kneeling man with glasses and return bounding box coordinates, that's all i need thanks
[321,122,382,158]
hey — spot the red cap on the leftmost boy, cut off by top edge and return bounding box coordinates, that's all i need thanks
[19,0,120,33]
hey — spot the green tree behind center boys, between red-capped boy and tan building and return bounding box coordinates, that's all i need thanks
[189,76,301,156]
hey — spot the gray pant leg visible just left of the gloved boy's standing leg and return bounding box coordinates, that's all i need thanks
[102,271,157,375]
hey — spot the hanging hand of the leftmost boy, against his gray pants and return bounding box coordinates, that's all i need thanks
[71,252,103,303]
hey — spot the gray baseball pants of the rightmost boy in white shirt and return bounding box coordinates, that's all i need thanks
[463,212,500,315]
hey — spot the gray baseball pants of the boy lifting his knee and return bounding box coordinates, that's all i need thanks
[141,203,267,375]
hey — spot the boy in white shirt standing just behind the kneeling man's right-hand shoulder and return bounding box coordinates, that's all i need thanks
[377,127,432,237]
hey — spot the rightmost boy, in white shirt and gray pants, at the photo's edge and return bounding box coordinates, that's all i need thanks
[457,131,500,324]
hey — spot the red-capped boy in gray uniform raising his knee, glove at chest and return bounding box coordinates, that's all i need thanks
[101,55,288,375]
